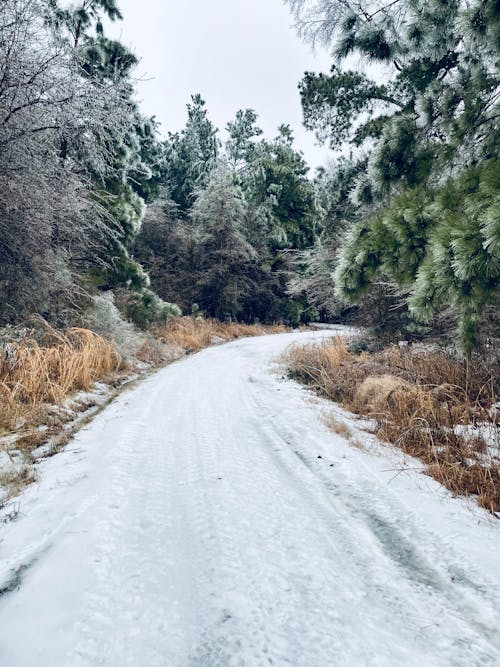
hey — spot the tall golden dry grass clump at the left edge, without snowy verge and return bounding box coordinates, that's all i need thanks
[0,327,120,430]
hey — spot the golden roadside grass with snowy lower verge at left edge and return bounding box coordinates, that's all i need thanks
[0,324,121,505]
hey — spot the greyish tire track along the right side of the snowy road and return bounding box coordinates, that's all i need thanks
[248,384,500,660]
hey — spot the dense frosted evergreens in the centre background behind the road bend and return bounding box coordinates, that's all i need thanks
[135,100,318,324]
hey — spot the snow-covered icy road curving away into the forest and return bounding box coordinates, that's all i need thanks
[0,332,500,667]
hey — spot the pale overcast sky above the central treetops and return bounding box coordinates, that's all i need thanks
[108,0,336,167]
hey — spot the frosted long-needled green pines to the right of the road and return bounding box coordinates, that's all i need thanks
[288,0,500,352]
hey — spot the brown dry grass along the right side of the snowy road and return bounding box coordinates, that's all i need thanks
[285,337,500,513]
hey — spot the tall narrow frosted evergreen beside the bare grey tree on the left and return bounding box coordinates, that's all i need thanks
[50,0,162,289]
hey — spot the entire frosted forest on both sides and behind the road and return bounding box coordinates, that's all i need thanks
[0,0,500,354]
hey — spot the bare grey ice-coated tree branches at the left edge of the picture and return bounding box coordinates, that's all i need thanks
[0,0,133,322]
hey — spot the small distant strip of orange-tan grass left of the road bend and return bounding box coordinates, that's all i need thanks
[154,317,287,352]
